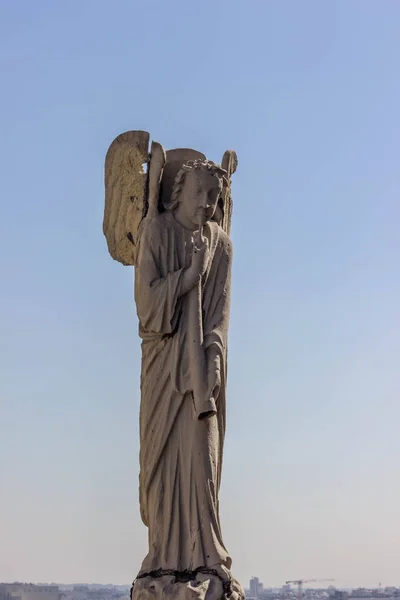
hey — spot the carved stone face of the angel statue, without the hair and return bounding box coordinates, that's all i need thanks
[177,169,221,229]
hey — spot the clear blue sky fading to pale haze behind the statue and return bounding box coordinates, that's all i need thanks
[0,0,400,585]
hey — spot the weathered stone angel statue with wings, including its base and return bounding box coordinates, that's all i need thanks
[103,131,244,600]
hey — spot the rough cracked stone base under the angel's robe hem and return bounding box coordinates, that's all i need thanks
[131,569,245,600]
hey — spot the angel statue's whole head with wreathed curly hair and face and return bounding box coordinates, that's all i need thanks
[164,160,227,230]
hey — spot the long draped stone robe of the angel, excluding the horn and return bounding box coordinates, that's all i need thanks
[135,211,232,574]
